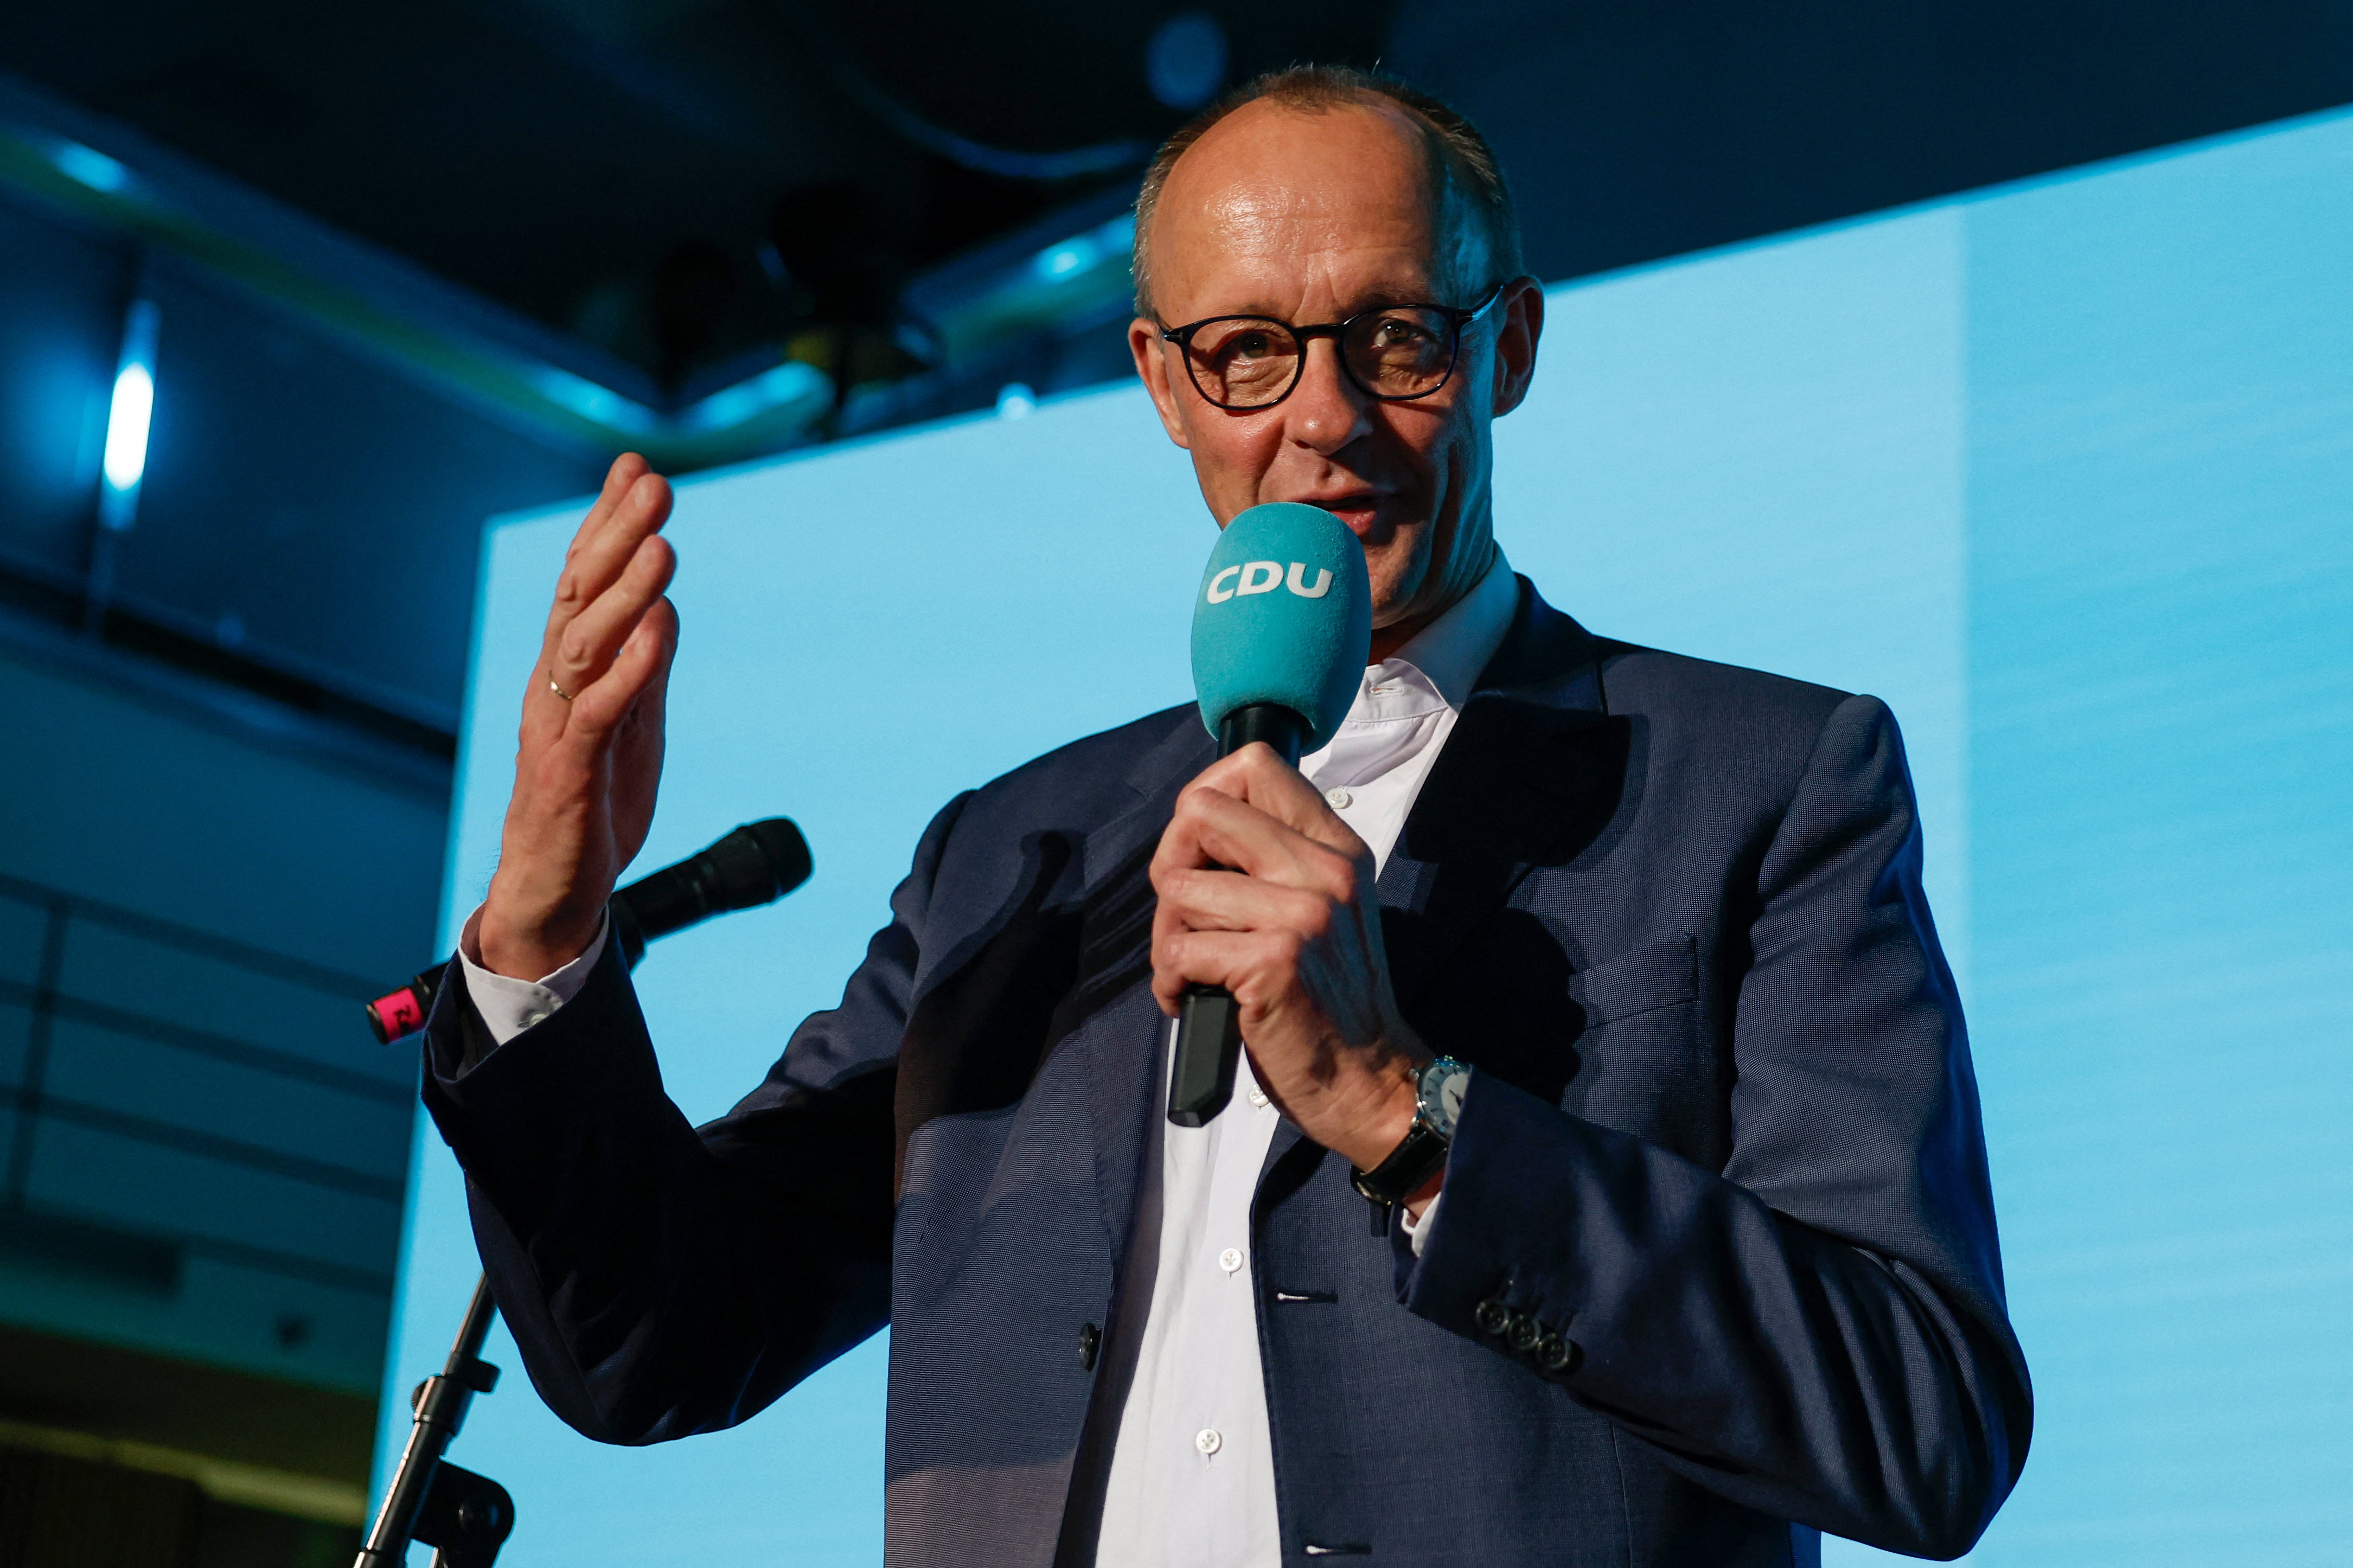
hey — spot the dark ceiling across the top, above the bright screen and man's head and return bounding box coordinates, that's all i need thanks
[0,0,2353,402]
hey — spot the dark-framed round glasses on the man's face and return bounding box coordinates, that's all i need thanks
[1160,283,1504,409]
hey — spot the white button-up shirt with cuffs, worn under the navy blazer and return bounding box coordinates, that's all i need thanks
[459,551,1520,1568]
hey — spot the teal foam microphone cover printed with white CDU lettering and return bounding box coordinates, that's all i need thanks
[1193,502,1372,751]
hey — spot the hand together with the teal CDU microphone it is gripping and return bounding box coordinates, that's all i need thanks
[1153,504,1428,1170]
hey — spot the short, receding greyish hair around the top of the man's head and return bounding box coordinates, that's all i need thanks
[1132,66,1523,316]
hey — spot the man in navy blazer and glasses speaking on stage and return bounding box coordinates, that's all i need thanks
[426,71,2031,1568]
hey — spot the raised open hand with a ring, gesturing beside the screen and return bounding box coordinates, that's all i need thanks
[475,452,677,980]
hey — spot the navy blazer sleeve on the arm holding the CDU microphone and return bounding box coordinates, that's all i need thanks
[1400,697,2033,1556]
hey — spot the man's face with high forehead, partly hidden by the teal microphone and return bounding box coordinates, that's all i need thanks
[1129,101,1544,640]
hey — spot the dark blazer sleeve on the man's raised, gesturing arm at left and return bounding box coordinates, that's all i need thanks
[424,796,967,1443]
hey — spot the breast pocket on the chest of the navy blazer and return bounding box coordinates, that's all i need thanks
[1560,932,1722,1159]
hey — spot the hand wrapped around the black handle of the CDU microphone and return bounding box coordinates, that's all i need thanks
[1153,746,1431,1170]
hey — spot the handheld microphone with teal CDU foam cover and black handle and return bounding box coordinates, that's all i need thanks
[1169,502,1372,1128]
